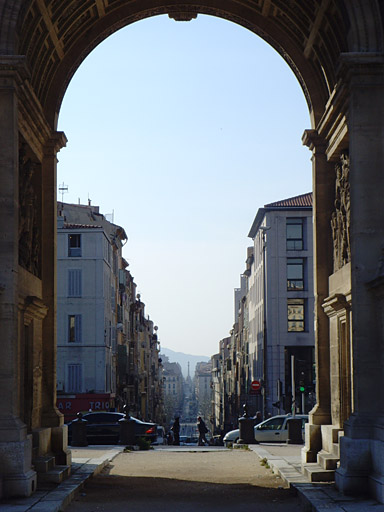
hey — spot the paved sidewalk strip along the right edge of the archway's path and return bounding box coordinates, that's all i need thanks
[249,443,384,512]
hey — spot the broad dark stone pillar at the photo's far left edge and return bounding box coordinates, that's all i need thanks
[0,57,36,496]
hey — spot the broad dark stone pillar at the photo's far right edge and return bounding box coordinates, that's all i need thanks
[336,53,384,501]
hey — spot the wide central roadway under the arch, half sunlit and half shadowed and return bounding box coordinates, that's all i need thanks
[66,448,301,512]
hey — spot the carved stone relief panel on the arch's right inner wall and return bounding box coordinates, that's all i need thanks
[331,153,351,272]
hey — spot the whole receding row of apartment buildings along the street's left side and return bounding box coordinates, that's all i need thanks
[57,203,163,421]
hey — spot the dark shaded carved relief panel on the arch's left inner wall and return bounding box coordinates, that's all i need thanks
[19,145,41,277]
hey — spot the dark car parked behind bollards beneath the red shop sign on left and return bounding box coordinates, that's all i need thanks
[68,412,157,445]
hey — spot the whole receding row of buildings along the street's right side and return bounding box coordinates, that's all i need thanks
[212,194,315,432]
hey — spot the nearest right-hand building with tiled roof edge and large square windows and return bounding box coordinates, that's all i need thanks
[247,193,315,417]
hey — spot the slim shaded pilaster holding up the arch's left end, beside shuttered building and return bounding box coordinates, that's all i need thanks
[41,132,69,464]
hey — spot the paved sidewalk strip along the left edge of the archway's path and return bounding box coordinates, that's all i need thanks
[0,446,124,512]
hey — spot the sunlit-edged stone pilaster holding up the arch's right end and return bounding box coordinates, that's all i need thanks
[302,130,335,462]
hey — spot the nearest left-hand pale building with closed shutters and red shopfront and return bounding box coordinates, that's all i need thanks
[57,205,126,420]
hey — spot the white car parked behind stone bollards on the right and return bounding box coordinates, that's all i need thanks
[223,414,308,446]
